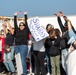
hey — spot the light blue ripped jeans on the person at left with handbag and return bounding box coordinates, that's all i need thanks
[3,47,15,72]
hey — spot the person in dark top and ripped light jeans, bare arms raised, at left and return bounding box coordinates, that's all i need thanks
[3,20,16,75]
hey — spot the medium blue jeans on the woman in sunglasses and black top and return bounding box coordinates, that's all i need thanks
[15,45,28,75]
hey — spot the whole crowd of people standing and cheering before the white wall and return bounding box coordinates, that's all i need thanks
[0,11,76,75]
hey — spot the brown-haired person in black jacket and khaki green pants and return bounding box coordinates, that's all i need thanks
[46,29,61,75]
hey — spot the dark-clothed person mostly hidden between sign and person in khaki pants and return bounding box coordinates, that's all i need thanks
[44,24,54,75]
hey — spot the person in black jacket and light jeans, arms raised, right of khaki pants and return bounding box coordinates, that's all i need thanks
[54,11,75,72]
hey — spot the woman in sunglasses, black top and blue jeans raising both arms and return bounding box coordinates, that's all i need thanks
[14,12,30,75]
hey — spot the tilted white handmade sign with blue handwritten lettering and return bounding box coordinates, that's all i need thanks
[27,17,48,41]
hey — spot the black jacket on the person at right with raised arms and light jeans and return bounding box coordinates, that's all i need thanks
[57,17,75,49]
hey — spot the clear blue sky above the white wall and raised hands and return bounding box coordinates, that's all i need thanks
[0,0,76,17]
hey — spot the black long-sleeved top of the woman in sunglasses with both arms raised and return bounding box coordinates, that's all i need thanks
[14,15,30,45]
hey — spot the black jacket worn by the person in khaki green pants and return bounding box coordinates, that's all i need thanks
[44,37,61,56]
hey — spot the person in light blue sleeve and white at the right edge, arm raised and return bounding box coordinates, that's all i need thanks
[66,19,76,75]
